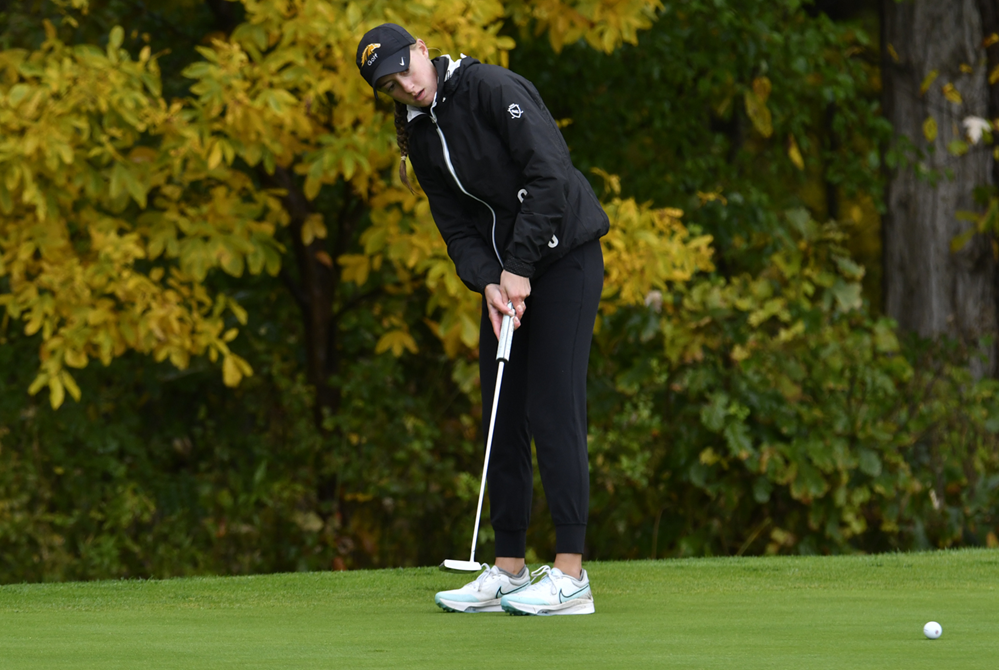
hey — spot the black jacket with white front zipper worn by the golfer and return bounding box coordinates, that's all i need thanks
[407,56,610,293]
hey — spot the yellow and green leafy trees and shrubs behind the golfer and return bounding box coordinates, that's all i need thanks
[0,0,999,582]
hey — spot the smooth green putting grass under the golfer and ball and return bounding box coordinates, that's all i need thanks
[0,550,999,670]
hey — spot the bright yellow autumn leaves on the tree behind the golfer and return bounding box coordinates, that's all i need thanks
[0,0,710,406]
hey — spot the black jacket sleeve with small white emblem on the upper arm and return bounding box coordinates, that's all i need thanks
[477,66,572,277]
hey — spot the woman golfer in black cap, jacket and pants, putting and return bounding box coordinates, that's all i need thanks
[357,23,609,614]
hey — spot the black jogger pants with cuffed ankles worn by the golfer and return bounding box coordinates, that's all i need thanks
[479,240,604,558]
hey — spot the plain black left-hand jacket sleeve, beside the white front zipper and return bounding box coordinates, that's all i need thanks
[409,143,503,293]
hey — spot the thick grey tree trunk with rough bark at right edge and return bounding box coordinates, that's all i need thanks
[882,0,999,375]
